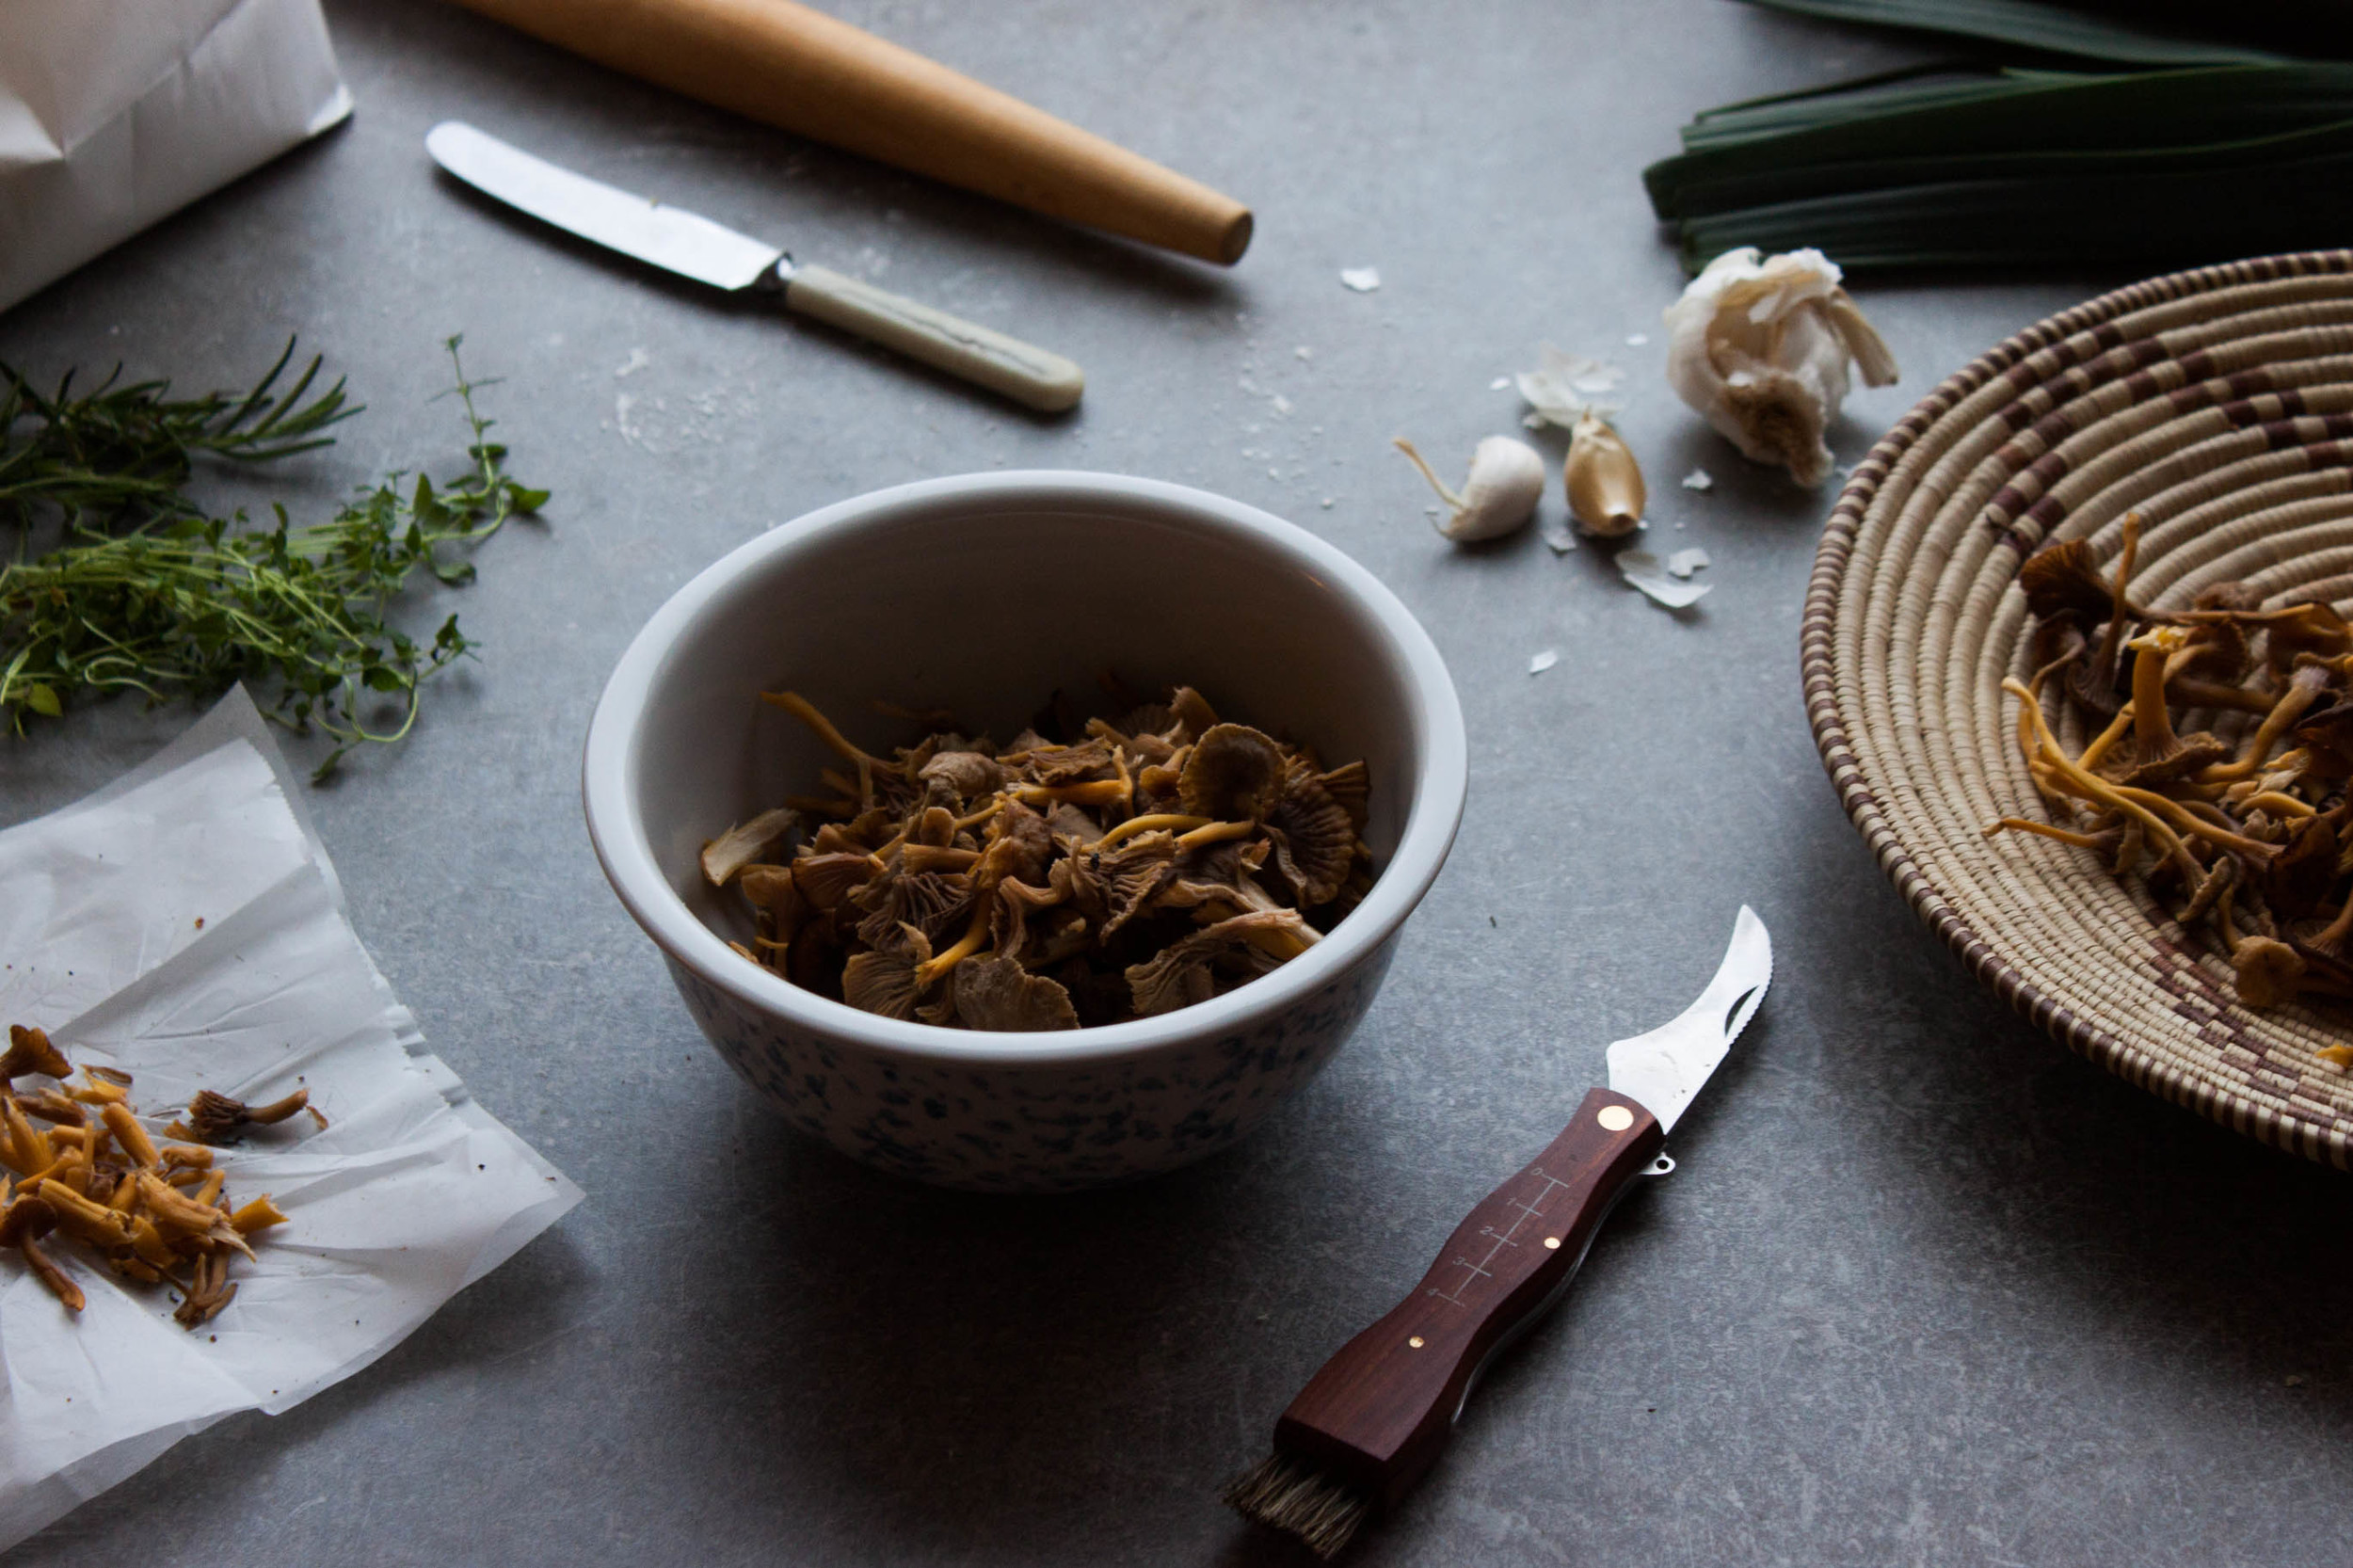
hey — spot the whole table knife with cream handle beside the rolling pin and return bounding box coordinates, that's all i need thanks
[426,120,1087,414]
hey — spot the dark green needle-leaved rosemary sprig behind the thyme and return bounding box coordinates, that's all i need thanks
[0,339,360,530]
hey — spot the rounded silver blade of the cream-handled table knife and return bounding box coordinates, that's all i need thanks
[426,120,791,290]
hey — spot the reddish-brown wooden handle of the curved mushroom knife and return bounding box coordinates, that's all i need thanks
[1275,1088,1666,1509]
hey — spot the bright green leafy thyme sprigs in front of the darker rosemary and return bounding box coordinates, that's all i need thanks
[0,337,549,776]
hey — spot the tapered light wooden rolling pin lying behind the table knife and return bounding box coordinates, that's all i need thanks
[442,0,1250,266]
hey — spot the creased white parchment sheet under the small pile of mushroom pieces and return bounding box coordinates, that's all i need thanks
[0,690,582,1549]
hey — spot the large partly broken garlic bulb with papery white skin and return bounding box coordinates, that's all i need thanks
[1666,245,1897,485]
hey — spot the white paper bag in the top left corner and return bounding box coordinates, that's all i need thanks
[0,0,351,311]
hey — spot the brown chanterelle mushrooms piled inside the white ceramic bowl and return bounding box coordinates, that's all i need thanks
[704,687,1372,1032]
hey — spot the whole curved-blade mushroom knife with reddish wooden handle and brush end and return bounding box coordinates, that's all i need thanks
[1226,904,1772,1556]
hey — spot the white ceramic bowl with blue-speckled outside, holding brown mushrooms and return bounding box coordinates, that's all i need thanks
[582,473,1466,1192]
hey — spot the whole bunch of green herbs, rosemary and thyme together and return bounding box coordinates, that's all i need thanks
[0,339,546,776]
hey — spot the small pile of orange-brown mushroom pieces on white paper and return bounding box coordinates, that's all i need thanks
[0,1024,298,1330]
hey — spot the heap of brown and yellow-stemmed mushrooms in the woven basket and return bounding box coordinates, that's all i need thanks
[1986,505,2353,1031]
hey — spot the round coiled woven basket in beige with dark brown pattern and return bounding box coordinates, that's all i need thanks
[1802,252,2353,1170]
